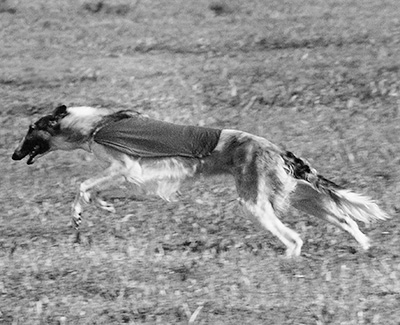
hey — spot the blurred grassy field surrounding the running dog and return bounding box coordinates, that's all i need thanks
[0,0,400,325]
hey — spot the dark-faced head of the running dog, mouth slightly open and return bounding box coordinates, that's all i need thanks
[12,105,68,165]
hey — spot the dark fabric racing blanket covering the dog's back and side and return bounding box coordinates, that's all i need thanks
[93,116,221,158]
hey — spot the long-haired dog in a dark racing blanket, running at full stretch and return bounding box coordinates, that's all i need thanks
[12,105,388,257]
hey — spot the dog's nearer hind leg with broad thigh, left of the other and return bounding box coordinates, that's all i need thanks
[233,142,303,257]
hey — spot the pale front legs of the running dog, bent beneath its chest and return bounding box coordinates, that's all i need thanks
[72,170,125,229]
